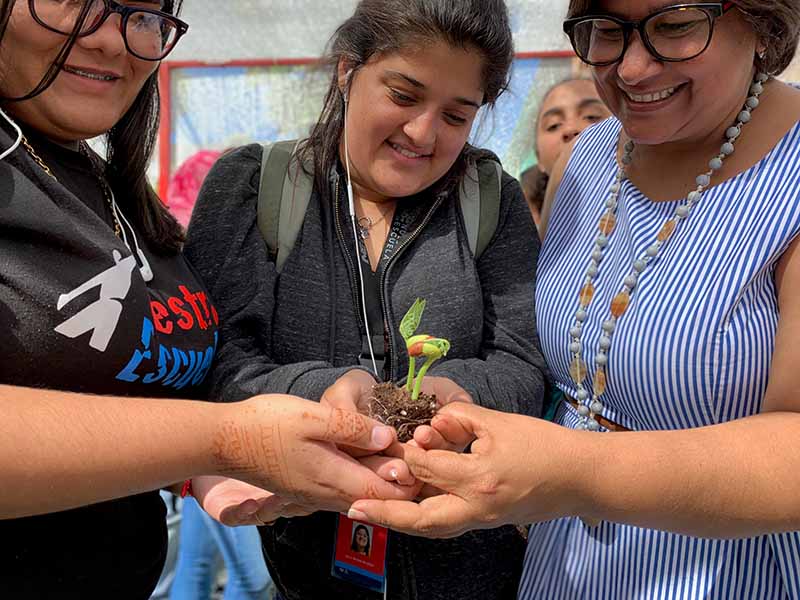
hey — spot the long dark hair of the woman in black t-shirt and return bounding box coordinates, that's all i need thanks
[0,0,184,254]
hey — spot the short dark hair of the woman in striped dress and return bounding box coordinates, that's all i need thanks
[567,0,800,75]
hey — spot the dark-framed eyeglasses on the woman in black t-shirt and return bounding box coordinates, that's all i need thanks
[28,0,189,60]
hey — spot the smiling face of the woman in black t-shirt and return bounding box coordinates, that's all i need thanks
[0,1,161,142]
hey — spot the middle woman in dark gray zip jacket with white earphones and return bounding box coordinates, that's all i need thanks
[186,0,544,600]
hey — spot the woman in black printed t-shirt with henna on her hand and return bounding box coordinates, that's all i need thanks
[0,0,410,598]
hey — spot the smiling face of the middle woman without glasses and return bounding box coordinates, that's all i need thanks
[339,42,483,201]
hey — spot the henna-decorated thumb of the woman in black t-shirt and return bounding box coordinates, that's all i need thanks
[305,405,397,452]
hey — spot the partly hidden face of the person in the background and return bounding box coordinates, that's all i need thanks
[536,79,611,175]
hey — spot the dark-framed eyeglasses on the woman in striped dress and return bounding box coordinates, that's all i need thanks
[564,2,735,67]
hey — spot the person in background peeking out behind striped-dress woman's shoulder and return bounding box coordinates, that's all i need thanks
[520,79,611,229]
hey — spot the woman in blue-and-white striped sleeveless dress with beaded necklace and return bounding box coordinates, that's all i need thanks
[352,0,800,599]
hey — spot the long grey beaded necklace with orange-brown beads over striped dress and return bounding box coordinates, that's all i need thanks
[569,73,769,431]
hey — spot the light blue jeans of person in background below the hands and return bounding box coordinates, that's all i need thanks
[169,497,272,600]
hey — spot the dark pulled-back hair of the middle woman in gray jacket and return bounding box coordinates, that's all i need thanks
[298,0,514,200]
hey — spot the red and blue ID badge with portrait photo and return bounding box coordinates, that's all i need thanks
[331,515,389,593]
